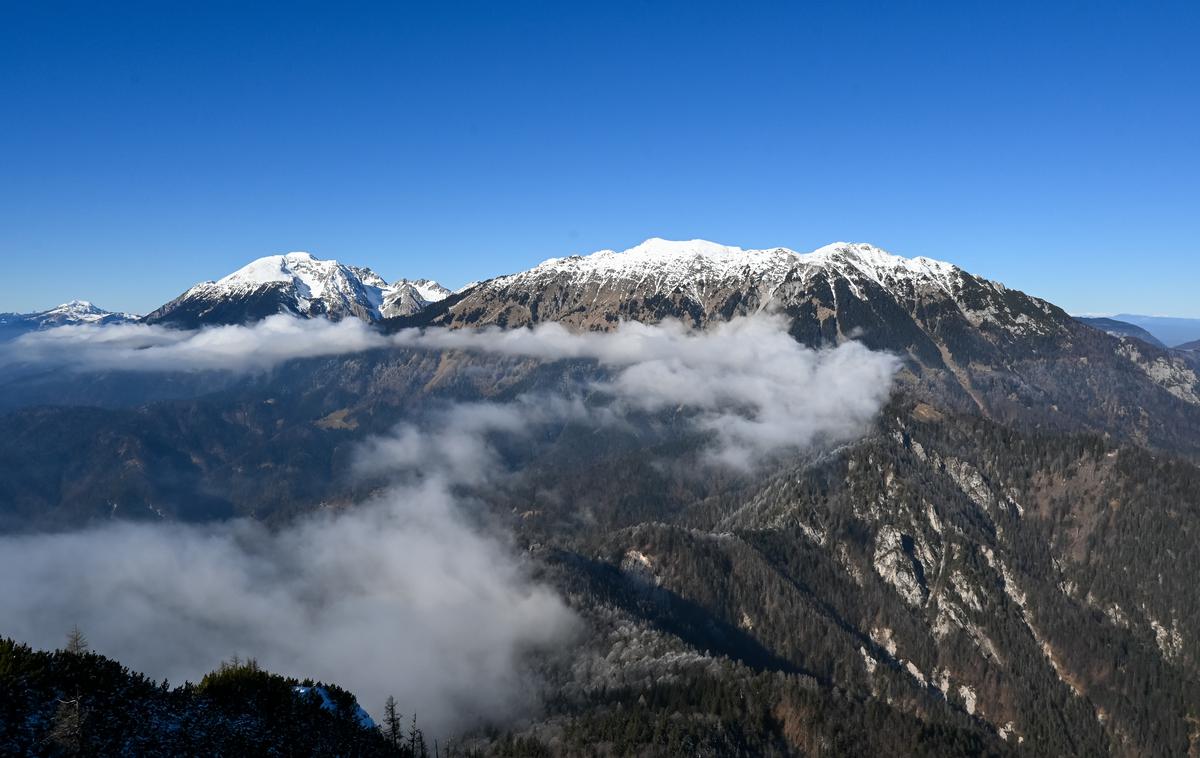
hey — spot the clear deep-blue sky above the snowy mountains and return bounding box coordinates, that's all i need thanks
[0,0,1200,317]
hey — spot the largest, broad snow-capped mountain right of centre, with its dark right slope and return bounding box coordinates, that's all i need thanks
[415,239,1200,446]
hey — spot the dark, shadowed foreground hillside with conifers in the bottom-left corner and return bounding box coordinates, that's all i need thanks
[0,638,403,756]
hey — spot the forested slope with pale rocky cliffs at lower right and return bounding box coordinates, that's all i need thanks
[514,405,1200,756]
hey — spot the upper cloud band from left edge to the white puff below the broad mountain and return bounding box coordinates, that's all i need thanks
[0,314,899,468]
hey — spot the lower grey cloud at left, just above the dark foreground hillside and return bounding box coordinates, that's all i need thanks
[0,414,577,734]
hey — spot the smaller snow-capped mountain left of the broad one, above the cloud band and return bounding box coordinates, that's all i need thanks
[145,252,449,327]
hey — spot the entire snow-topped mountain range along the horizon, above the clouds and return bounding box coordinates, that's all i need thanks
[2,239,1200,450]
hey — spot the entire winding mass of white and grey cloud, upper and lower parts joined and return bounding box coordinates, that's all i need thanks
[0,315,898,733]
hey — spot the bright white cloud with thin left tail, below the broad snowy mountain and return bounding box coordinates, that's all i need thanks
[392,314,900,469]
